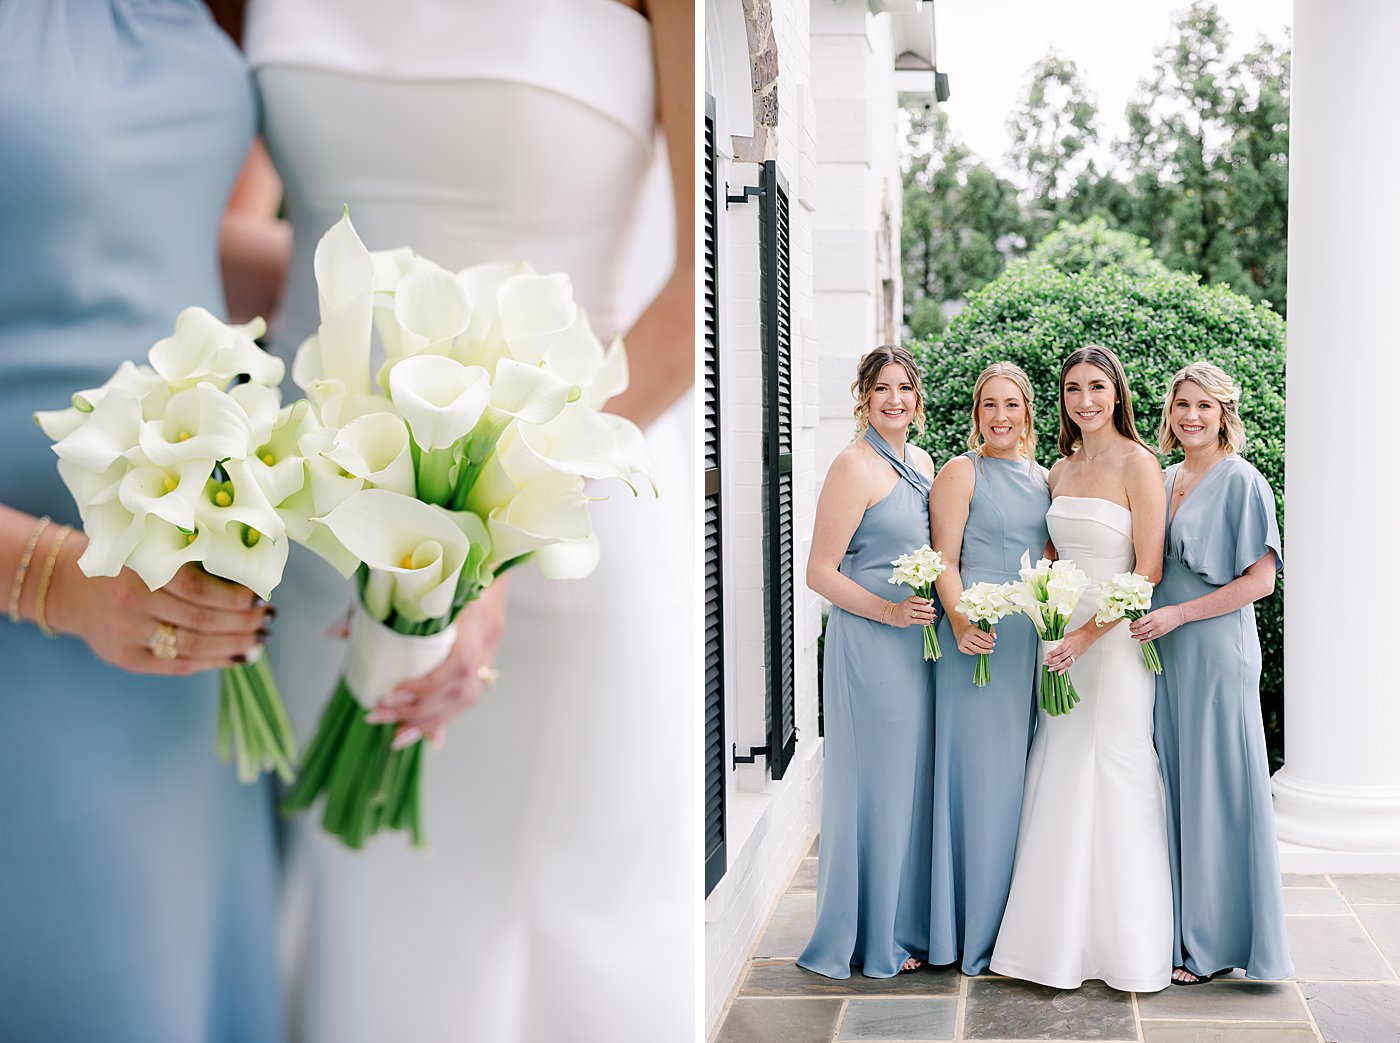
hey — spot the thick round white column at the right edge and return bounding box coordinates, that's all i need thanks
[1274,0,1400,872]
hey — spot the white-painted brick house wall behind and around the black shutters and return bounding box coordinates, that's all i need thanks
[706,0,899,1030]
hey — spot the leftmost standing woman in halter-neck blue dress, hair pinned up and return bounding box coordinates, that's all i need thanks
[798,346,934,979]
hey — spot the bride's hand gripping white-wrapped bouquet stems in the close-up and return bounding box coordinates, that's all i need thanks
[365,580,507,749]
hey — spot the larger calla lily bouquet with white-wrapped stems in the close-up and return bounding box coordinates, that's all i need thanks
[284,211,654,847]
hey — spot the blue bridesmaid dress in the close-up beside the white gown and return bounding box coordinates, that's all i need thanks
[0,0,283,1043]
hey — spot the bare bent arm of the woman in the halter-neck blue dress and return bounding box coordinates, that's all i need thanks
[806,451,934,627]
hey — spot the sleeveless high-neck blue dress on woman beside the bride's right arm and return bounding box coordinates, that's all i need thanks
[928,452,1050,974]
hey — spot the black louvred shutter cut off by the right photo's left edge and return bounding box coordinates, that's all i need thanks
[704,95,727,895]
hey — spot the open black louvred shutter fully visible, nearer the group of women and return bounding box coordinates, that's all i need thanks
[759,160,797,778]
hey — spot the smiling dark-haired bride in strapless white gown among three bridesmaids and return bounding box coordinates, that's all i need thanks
[991,346,1172,993]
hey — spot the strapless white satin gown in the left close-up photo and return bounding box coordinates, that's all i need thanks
[246,0,699,1043]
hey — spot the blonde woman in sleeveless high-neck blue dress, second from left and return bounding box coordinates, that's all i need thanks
[928,363,1050,974]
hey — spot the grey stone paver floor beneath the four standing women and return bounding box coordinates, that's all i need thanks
[711,843,1400,1043]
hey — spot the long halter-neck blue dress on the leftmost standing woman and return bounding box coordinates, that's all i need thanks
[798,428,934,979]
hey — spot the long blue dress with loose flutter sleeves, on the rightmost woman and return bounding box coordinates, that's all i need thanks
[1152,455,1294,979]
